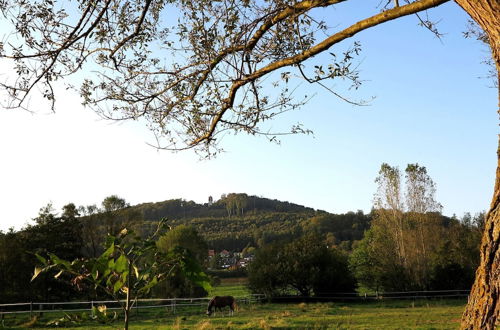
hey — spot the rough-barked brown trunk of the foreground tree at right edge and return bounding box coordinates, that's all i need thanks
[455,0,500,329]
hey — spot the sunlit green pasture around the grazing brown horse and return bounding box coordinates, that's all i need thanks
[0,280,465,330]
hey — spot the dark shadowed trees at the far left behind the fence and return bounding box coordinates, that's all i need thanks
[0,204,86,303]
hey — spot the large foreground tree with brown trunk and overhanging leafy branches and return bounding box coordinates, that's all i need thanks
[0,0,500,329]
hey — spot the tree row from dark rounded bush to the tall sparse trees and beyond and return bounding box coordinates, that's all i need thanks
[248,164,484,296]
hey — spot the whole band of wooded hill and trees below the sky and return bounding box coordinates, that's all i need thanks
[0,164,484,303]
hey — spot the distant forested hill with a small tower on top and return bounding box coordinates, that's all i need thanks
[82,193,370,251]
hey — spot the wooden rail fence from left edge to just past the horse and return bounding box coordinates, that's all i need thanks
[0,294,264,317]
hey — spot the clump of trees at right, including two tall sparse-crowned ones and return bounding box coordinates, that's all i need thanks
[351,164,484,291]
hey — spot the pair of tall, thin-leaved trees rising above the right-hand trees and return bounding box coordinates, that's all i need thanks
[368,163,444,289]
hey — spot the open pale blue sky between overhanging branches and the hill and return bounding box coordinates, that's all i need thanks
[0,1,498,230]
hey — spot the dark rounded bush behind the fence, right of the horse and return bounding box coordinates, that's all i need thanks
[248,234,355,296]
